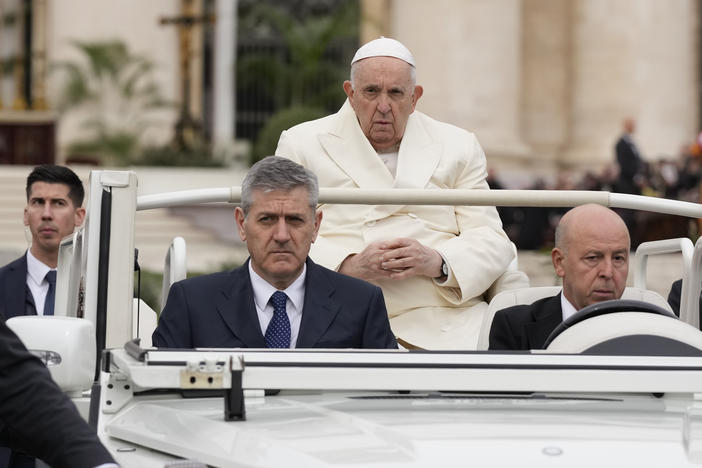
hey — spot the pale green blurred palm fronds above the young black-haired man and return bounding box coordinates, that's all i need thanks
[52,40,172,165]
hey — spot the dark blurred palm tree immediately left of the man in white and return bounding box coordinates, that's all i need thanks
[237,1,358,163]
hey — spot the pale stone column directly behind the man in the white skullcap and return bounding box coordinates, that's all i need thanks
[390,0,529,165]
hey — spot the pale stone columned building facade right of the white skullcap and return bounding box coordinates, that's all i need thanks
[362,0,702,186]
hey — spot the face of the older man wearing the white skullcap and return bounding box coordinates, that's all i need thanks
[344,57,422,151]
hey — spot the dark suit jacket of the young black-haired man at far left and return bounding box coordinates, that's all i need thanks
[0,254,37,319]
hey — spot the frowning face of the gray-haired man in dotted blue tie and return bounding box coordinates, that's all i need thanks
[234,187,322,289]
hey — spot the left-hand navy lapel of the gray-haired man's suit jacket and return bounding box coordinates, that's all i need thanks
[215,261,266,348]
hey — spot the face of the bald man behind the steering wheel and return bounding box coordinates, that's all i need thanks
[551,208,629,310]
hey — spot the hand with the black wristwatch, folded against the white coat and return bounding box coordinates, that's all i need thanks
[380,237,442,280]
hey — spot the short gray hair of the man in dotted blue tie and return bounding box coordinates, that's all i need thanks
[241,156,319,216]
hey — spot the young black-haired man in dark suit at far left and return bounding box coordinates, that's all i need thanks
[0,164,85,318]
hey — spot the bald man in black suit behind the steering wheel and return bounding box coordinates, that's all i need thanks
[489,204,630,350]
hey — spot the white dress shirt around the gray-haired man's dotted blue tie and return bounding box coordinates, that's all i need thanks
[249,261,307,348]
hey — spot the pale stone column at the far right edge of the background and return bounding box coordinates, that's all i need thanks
[560,0,699,167]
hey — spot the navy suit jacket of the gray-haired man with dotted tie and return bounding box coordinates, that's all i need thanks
[152,258,397,348]
